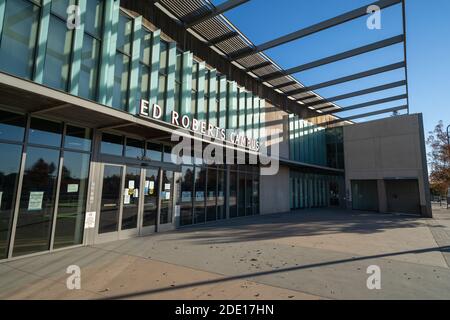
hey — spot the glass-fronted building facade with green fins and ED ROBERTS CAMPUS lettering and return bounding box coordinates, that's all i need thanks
[0,0,428,260]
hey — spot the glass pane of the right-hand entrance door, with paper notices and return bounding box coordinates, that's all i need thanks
[142,169,159,227]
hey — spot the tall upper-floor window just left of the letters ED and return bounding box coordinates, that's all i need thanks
[112,14,133,110]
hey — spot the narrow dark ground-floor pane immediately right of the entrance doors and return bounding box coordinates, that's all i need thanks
[178,167,194,226]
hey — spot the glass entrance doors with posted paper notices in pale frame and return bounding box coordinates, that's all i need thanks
[94,164,174,243]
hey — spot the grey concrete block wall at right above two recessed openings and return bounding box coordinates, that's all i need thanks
[344,114,431,217]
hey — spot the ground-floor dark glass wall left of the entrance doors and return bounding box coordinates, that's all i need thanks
[0,111,92,259]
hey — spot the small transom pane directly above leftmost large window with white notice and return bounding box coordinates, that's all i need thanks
[28,118,62,147]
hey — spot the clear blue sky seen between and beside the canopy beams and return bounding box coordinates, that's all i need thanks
[213,0,450,138]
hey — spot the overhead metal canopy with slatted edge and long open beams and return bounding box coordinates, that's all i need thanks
[152,0,409,125]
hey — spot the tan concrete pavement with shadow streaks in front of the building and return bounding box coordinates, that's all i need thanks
[0,209,450,299]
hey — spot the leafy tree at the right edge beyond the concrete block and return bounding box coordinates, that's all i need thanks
[427,121,450,196]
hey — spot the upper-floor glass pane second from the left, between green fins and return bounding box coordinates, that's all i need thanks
[44,16,73,90]
